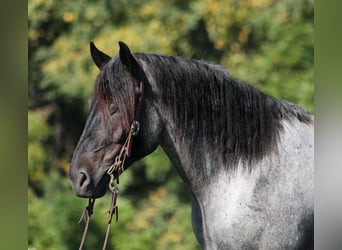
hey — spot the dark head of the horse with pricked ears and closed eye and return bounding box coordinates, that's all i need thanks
[69,42,160,198]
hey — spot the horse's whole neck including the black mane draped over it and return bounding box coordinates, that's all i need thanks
[142,56,309,192]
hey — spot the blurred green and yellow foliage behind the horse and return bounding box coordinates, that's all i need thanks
[28,0,314,250]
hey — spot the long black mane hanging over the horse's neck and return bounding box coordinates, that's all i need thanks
[135,53,312,171]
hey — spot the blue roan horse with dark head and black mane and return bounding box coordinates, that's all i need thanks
[70,42,314,250]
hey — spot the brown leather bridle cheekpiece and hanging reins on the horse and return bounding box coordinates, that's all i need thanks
[79,81,144,250]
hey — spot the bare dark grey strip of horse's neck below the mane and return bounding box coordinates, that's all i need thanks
[142,62,230,190]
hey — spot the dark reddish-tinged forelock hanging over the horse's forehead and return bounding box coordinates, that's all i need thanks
[93,57,135,129]
